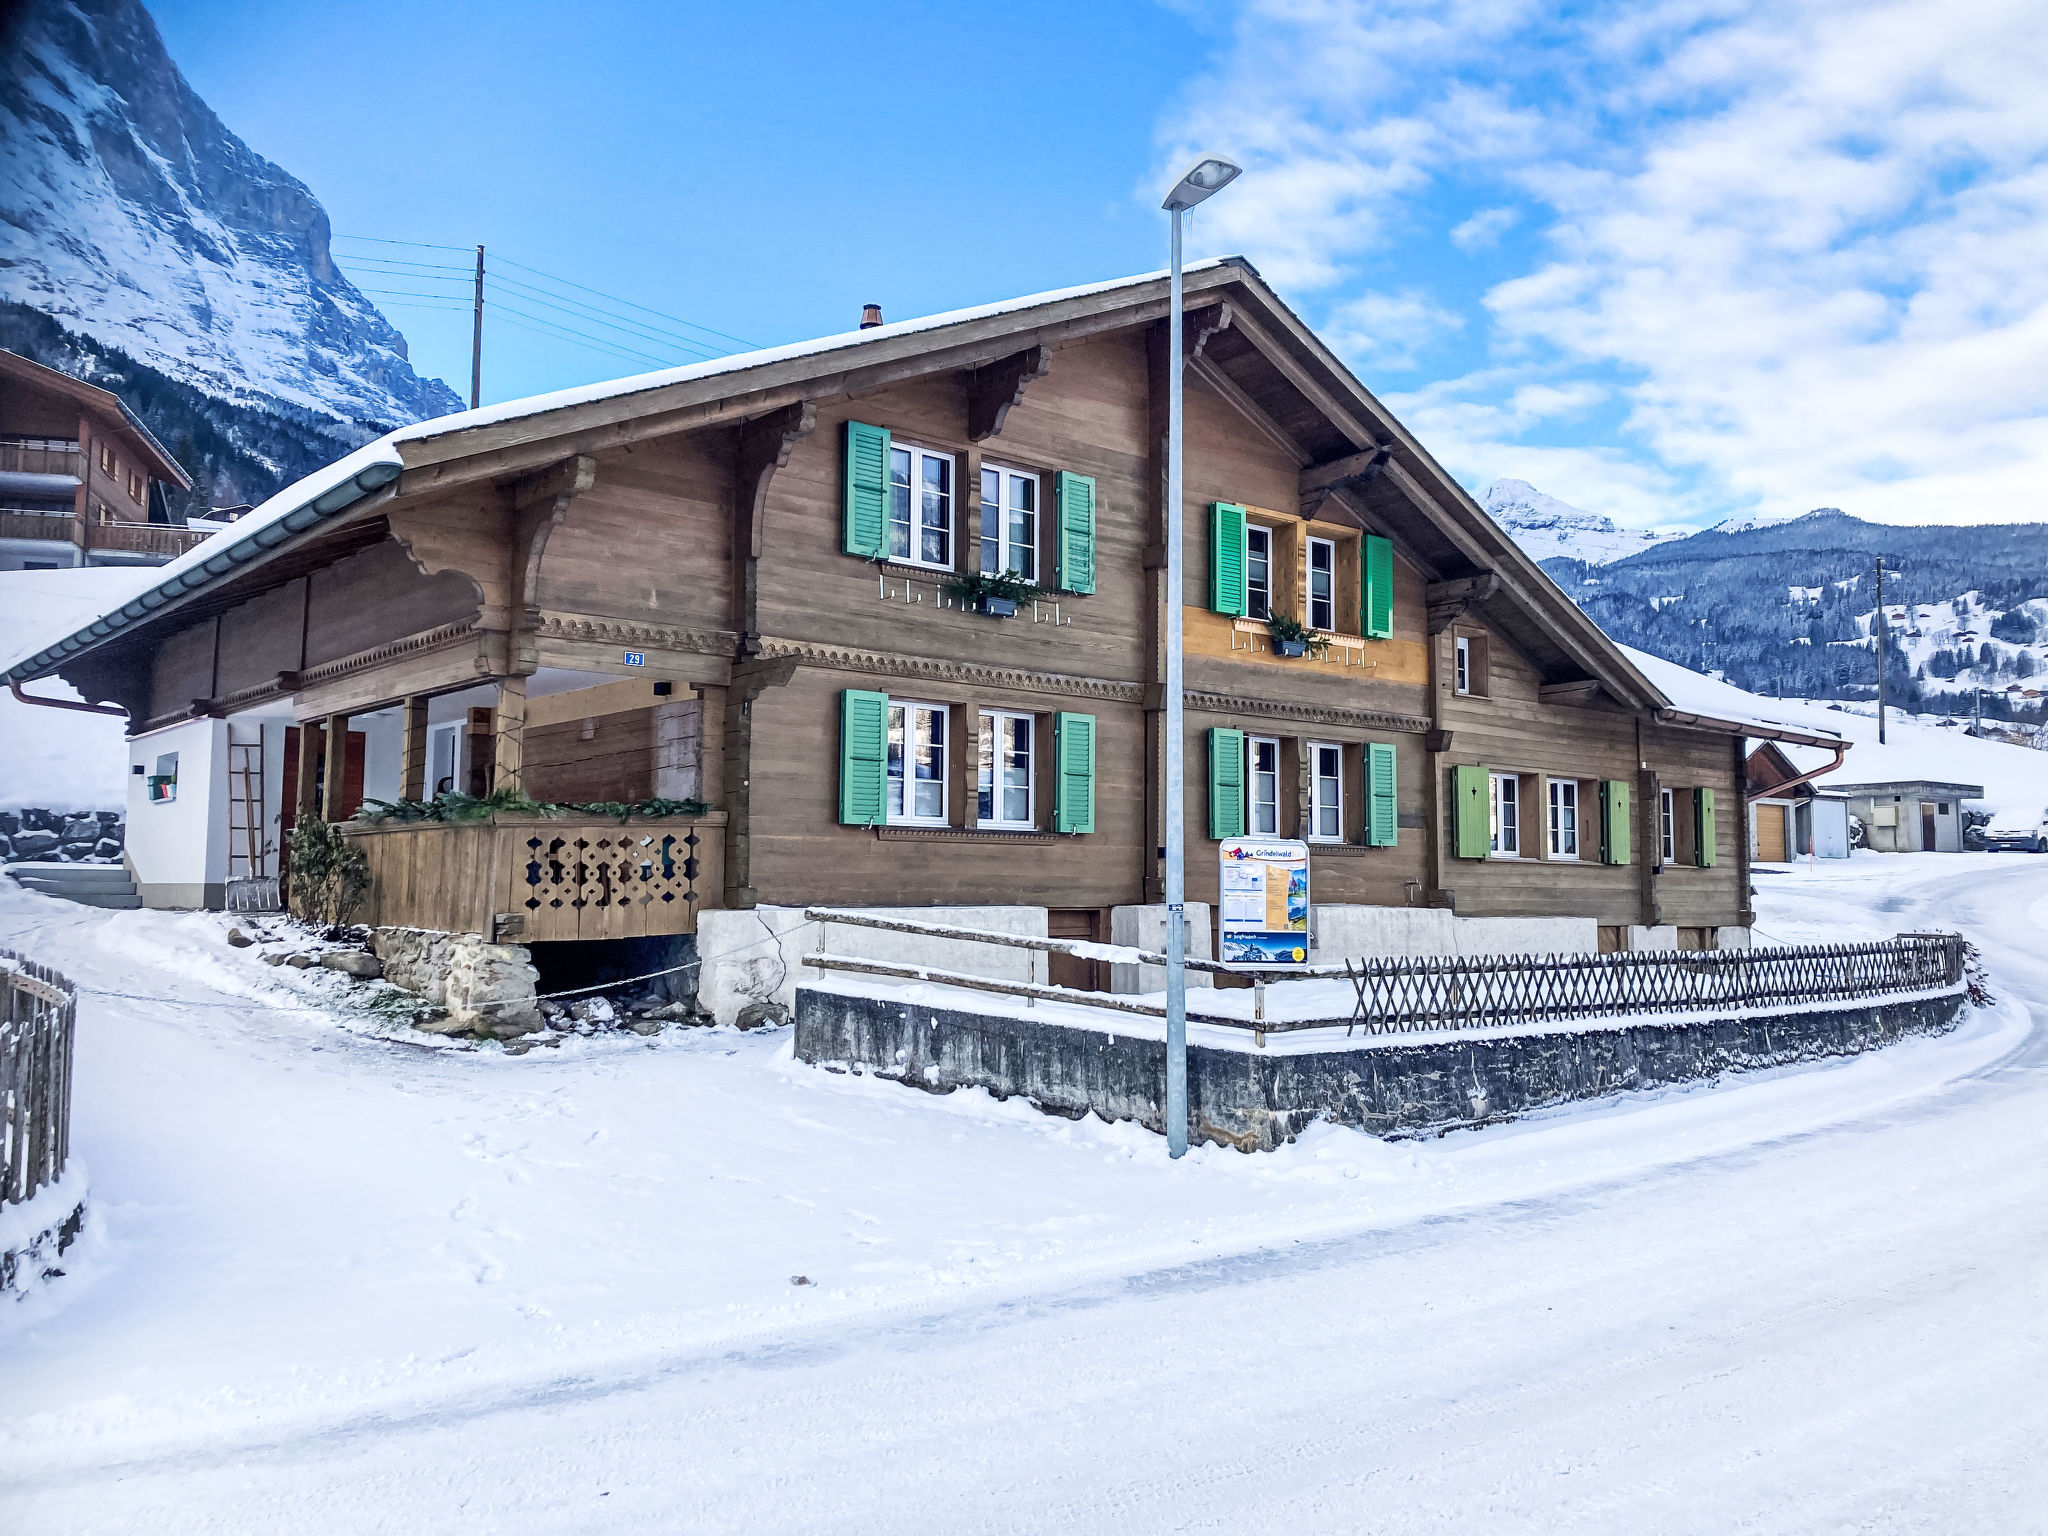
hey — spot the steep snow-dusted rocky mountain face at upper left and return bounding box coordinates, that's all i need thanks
[0,0,461,438]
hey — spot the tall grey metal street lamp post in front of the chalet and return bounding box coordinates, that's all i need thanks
[1159,156,1243,1157]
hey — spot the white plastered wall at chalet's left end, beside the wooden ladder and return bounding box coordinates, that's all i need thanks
[127,721,227,907]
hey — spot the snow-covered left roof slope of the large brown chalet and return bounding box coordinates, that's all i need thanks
[0,256,1249,682]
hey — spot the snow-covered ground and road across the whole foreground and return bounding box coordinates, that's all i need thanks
[0,854,2048,1532]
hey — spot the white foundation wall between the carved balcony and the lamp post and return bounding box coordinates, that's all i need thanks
[696,907,1047,1024]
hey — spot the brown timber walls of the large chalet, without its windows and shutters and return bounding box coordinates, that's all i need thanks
[8,260,1818,938]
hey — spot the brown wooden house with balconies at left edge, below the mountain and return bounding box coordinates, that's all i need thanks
[0,350,209,571]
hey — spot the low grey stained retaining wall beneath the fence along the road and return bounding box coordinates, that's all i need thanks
[797,987,1964,1151]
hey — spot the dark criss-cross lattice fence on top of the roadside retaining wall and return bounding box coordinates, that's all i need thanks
[1327,934,1962,1034]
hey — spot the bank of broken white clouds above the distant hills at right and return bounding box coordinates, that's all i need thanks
[1167,0,2048,522]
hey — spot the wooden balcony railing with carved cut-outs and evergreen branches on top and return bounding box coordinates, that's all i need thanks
[344,811,725,944]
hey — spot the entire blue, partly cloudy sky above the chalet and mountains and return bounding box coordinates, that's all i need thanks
[154,0,2048,526]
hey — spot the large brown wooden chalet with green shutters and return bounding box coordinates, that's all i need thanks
[10,258,1821,1015]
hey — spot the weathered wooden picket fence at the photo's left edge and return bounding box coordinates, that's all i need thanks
[0,950,78,1204]
